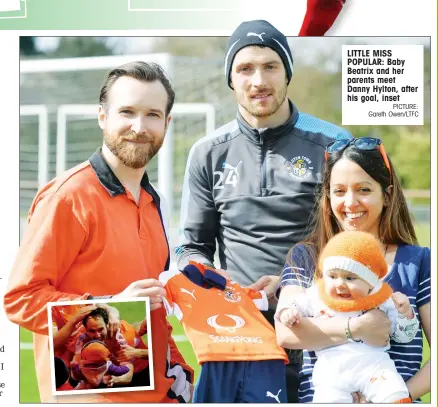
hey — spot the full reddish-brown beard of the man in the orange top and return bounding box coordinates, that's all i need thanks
[103,130,164,169]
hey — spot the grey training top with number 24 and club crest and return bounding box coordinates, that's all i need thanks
[176,102,351,285]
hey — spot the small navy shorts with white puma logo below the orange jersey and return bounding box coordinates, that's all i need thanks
[193,360,287,403]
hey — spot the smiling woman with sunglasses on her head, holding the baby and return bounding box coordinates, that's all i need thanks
[276,138,431,403]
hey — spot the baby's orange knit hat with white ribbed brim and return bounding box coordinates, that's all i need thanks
[319,231,388,287]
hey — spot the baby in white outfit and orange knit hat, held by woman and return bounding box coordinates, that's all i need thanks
[275,232,419,403]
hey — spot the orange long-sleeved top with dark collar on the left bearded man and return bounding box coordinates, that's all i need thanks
[4,151,193,403]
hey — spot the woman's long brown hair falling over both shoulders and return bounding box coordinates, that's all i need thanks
[287,145,418,280]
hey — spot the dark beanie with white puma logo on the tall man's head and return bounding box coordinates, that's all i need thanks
[225,20,293,89]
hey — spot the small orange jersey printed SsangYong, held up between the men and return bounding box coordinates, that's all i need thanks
[159,270,288,364]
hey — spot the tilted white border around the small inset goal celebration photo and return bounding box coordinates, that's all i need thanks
[47,297,155,396]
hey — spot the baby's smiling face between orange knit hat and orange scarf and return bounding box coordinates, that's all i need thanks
[324,269,372,300]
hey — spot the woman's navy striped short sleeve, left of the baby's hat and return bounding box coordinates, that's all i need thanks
[275,245,315,299]
